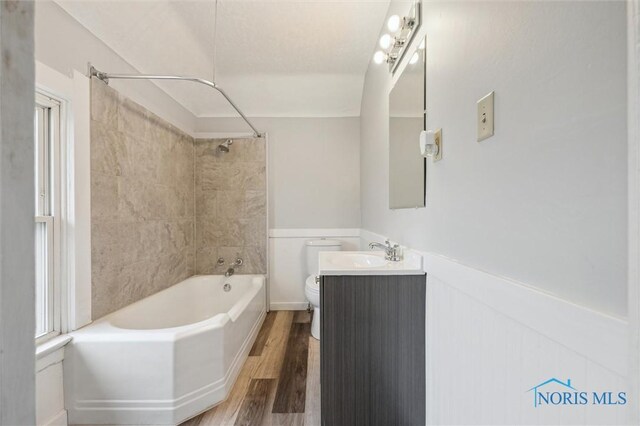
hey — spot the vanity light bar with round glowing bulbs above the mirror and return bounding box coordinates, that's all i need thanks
[373,0,424,73]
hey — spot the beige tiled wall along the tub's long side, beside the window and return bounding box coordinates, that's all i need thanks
[91,79,195,319]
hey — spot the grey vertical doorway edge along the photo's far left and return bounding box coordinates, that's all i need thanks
[0,2,35,425]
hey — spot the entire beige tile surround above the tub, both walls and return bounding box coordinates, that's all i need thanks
[91,79,267,319]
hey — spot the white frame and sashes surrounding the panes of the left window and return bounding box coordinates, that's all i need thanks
[34,88,66,345]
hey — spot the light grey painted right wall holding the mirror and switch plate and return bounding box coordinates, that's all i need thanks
[361,2,627,317]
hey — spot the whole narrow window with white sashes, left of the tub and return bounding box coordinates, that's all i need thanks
[35,93,62,342]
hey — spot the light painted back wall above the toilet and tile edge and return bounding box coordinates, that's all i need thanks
[197,117,360,228]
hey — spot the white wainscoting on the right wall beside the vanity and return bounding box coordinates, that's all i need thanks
[361,230,634,425]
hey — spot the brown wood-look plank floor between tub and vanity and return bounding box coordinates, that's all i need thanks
[181,311,320,426]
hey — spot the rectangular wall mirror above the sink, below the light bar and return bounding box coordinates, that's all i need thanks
[389,39,426,209]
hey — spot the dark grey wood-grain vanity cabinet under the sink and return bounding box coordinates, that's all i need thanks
[320,275,426,426]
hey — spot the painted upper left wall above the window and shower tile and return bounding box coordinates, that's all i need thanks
[35,1,196,133]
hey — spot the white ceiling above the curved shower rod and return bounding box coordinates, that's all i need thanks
[57,0,389,117]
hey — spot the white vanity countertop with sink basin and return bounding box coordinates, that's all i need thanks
[318,250,424,276]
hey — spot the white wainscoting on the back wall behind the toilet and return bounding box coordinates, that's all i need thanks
[269,229,360,311]
